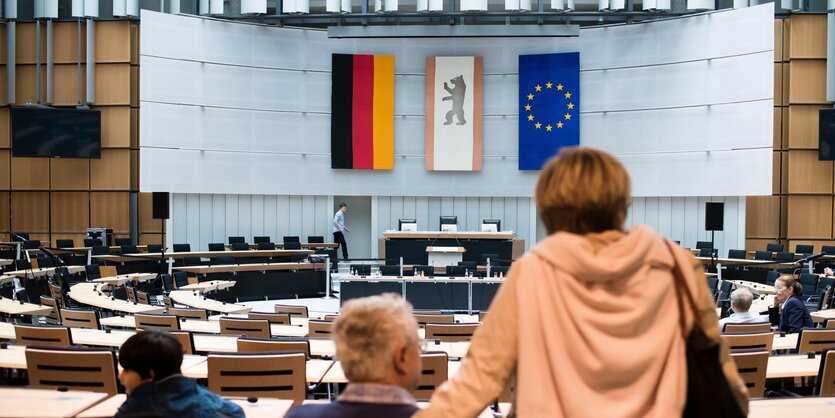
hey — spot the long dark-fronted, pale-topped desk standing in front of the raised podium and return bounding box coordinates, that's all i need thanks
[334,276,504,313]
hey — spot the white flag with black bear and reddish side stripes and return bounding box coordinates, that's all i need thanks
[426,57,484,171]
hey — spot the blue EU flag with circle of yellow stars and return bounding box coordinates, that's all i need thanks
[519,52,580,170]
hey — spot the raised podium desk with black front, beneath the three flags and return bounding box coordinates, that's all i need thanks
[378,231,525,265]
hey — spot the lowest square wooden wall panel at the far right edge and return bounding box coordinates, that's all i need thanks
[787,196,832,239]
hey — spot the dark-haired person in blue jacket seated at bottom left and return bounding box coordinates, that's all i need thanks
[115,331,244,418]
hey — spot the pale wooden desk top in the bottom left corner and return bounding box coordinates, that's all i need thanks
[0,387,108,418]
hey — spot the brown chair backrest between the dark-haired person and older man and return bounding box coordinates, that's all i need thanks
[207,353,307,405]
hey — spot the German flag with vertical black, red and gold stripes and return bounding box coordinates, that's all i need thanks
[331,54,394,170]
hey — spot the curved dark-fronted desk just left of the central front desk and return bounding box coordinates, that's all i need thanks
[174,262,328,303]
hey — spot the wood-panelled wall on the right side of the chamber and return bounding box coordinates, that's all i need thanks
[746,14,835,250]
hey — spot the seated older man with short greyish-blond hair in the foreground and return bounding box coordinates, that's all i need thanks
[286,293,421,418]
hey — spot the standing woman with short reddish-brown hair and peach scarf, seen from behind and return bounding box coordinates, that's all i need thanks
[416,148,747,418]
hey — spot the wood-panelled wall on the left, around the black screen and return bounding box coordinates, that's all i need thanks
[0,20,145,244]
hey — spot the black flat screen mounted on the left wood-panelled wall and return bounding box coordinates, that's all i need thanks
[11,107,101,158]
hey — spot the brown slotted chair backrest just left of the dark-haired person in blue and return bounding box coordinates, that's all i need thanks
[26,347,119,395]
